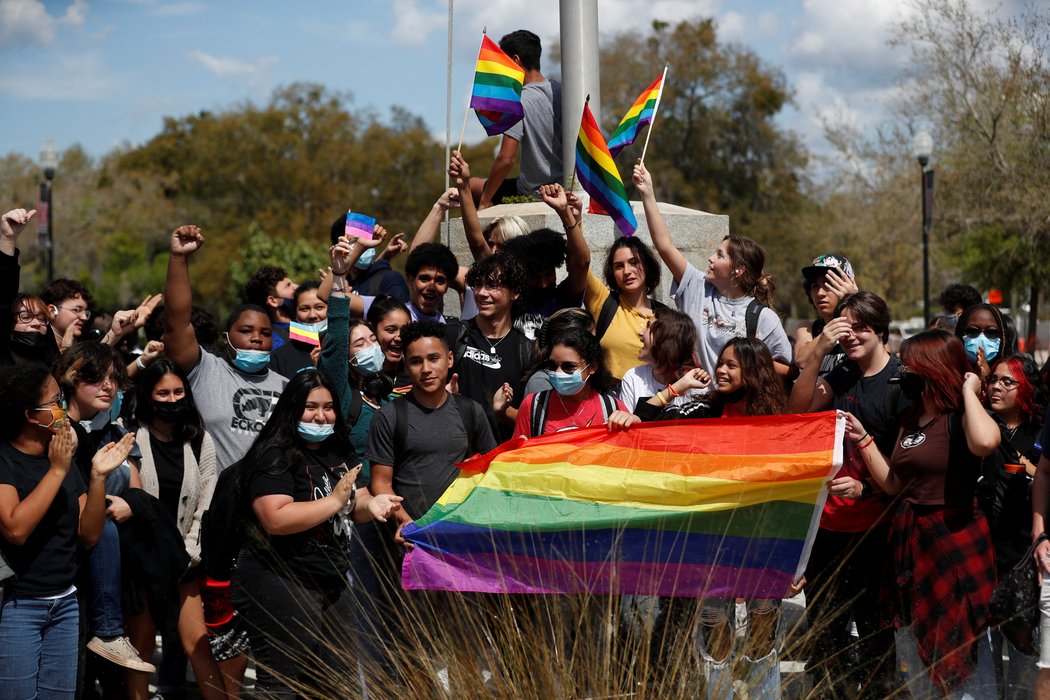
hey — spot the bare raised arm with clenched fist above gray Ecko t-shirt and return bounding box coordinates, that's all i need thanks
[164,226,204,372]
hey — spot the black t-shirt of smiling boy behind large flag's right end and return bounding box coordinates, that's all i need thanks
[824,357,911,455]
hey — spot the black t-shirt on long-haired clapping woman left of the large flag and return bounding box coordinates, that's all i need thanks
[246,446,353,586]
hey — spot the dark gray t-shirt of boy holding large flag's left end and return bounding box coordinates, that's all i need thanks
[364,394,496,519]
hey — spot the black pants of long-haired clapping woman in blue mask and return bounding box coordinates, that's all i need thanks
[233,550,359,697]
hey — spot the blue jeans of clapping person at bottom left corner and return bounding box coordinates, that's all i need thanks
[0,593,80,700]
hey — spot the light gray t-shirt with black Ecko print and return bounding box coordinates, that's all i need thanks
[189,348,288,472]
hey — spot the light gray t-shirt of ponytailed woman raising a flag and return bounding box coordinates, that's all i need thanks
[671,262,792,376]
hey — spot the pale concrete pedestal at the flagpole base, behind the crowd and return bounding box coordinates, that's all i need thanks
[441,193,729,316]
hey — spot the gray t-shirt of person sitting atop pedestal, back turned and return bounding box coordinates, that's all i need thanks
[505,80,562,194]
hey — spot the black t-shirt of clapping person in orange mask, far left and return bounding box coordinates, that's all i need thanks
[0,443,87,598]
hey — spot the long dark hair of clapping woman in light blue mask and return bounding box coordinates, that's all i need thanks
[236,368,353,493]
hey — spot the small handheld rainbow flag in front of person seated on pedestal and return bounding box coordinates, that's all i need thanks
[461,35,525,136]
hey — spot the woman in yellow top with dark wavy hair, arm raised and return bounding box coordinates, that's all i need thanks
[540,178,665,380]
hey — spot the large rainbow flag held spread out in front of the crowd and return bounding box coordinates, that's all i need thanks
[401,411,843,598]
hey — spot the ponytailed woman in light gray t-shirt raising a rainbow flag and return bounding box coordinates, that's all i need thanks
[633,161,794,377]
